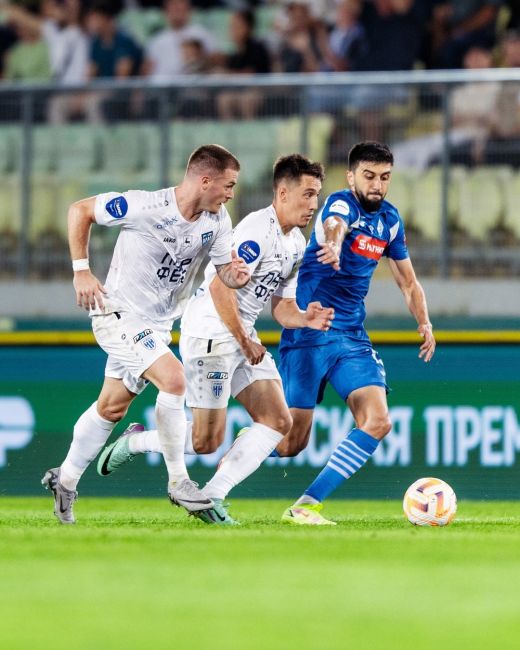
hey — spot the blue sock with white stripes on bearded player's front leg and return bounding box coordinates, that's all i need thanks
[304,429,379,501]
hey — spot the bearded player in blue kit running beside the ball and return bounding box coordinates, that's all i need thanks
[274,142,435,525]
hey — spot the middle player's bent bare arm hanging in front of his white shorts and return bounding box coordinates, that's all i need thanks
[209,276,266,366]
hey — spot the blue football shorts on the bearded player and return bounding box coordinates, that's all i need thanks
[278,330,389,409]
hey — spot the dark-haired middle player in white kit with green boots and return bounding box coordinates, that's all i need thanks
[98,154,337,524]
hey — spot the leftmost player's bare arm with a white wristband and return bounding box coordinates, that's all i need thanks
[67,197,106,310]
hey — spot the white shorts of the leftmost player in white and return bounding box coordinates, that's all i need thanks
[92,312,173,395]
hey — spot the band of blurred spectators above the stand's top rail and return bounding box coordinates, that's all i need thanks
[0,0,520,85]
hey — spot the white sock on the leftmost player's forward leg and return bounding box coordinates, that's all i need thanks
[155,391,188,483]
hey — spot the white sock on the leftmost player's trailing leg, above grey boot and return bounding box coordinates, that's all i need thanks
[60,402,117,490]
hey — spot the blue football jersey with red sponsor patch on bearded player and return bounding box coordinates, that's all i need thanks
[281,190,408,346]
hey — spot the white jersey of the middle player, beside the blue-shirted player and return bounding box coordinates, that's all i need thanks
[181,206,306,339]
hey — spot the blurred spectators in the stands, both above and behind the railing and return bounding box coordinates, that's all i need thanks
[0,0,520,161]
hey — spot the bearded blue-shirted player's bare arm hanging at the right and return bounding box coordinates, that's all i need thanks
[389,259,436,362]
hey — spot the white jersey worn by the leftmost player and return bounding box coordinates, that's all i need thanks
[91,188,232,328]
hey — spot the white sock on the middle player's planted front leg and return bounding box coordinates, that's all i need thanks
[204,422,283,499]
